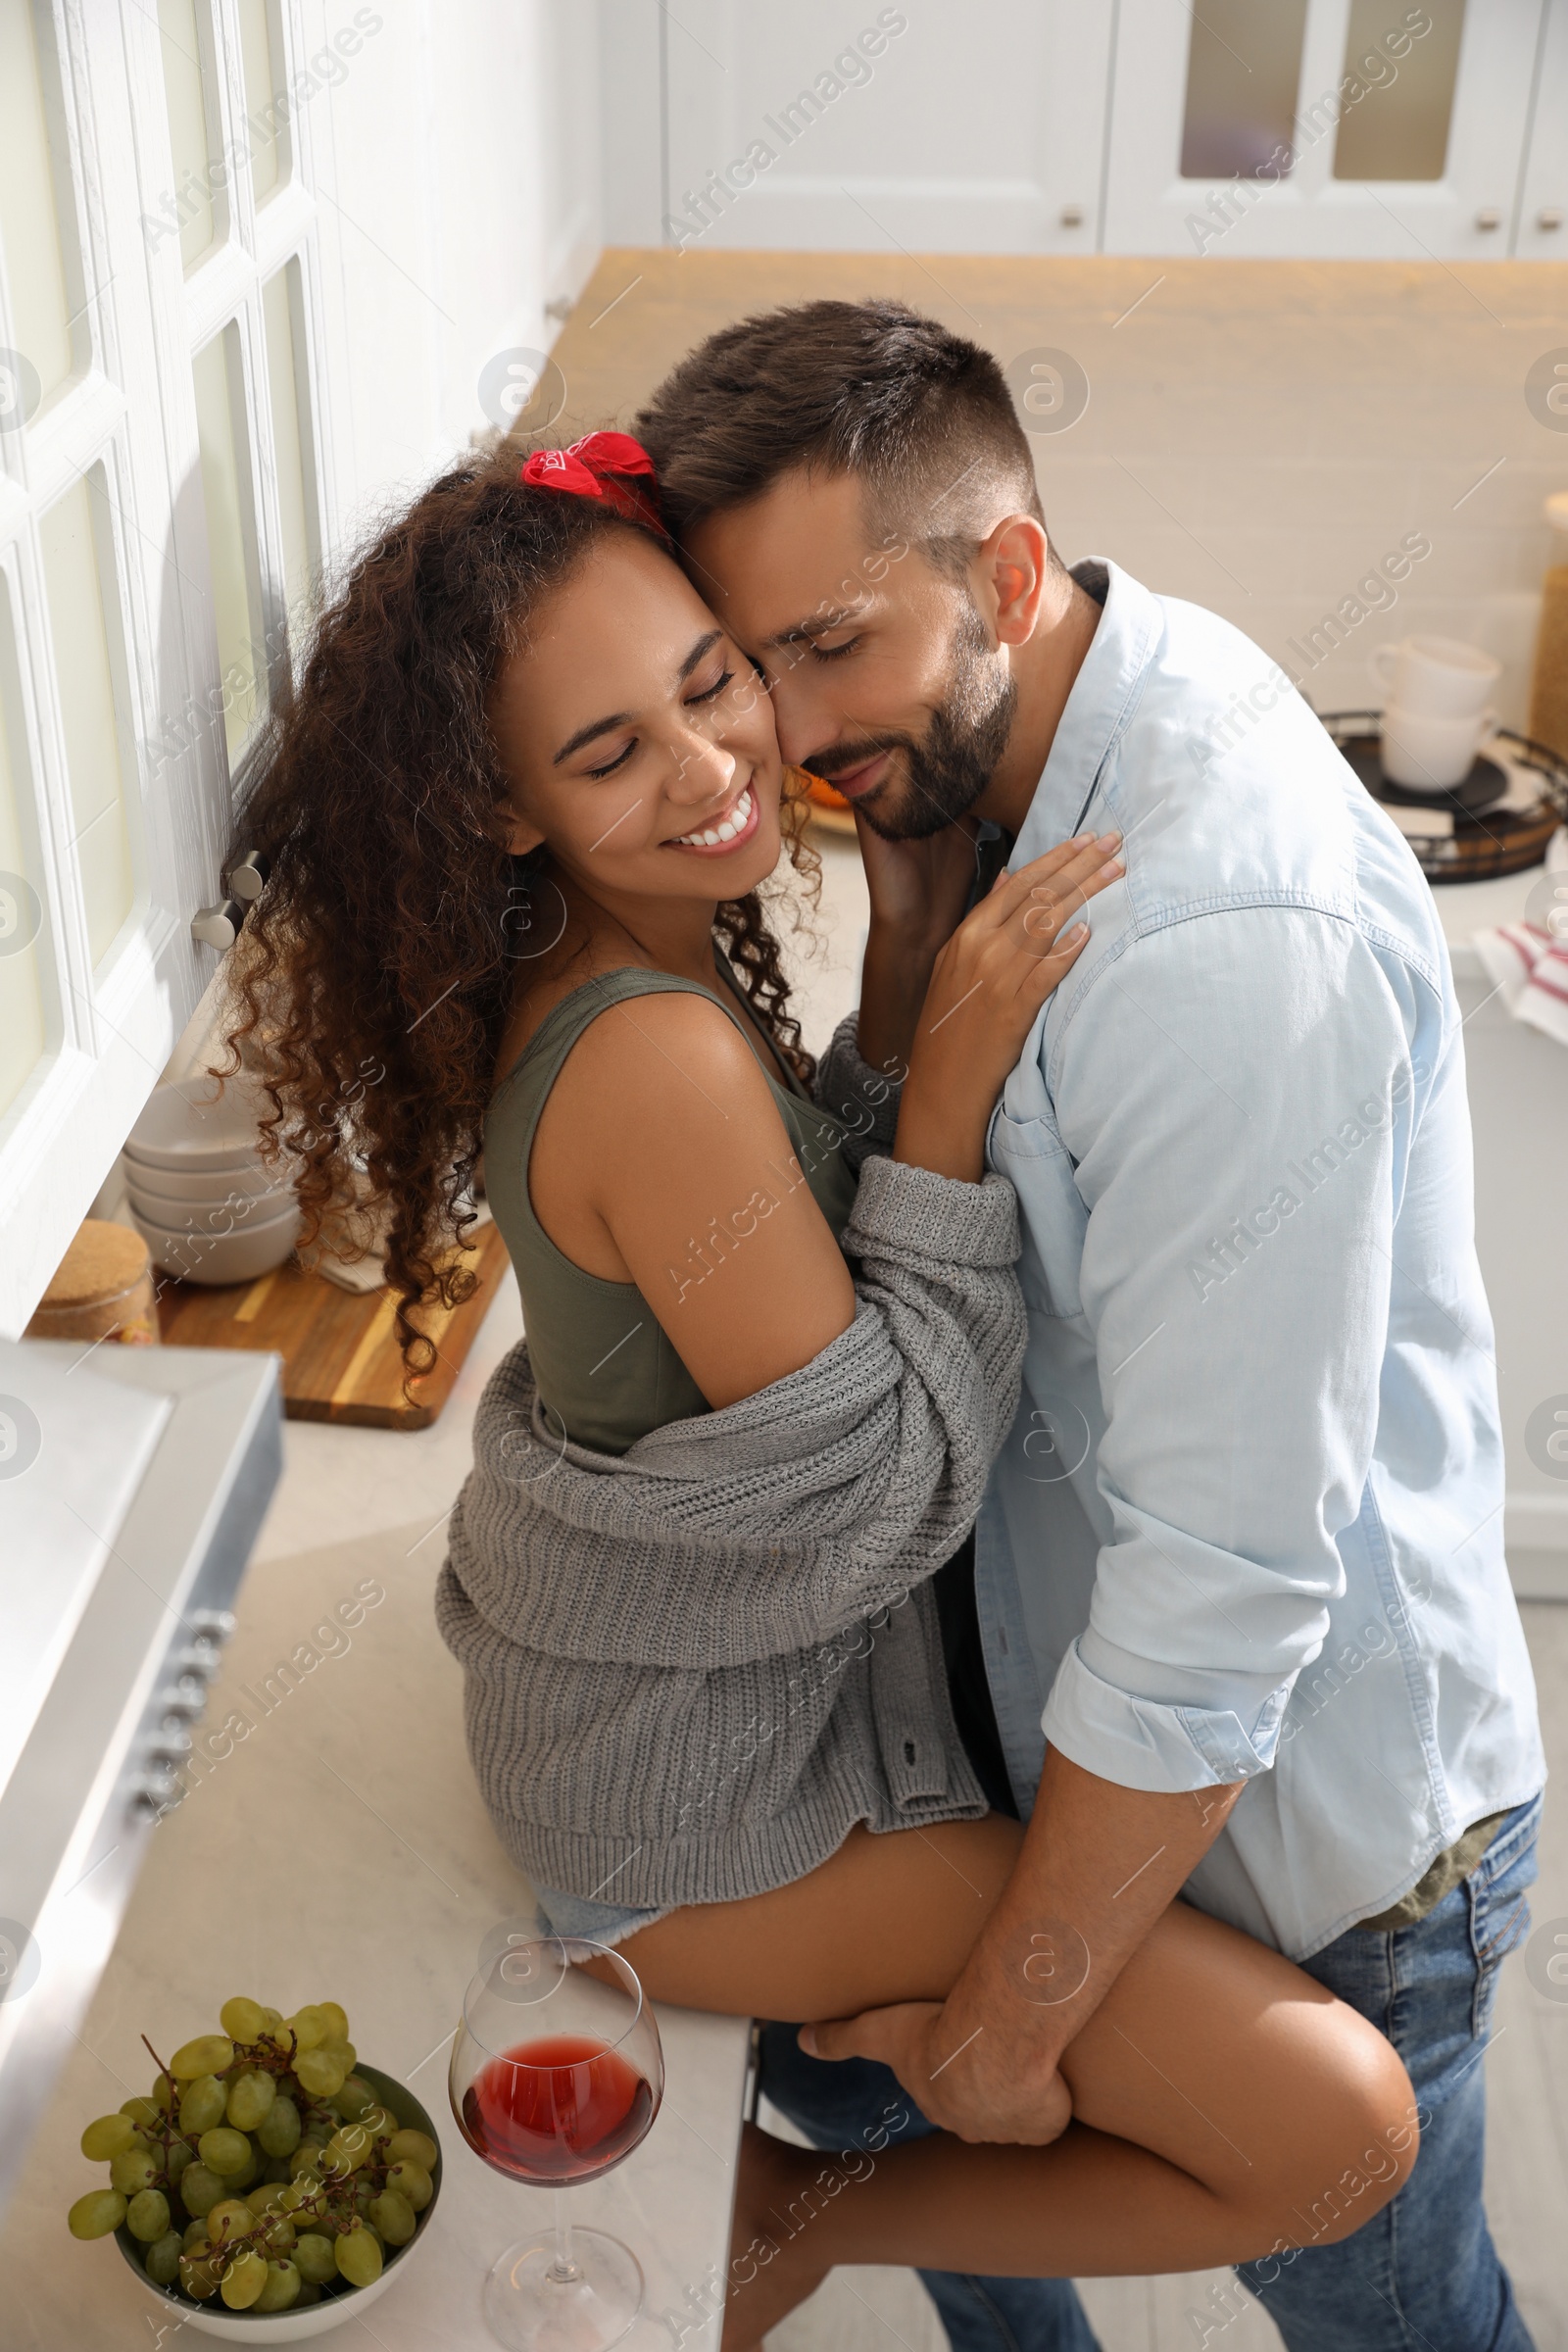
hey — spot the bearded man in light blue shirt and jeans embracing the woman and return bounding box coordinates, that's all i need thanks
[637,304,1544,2352]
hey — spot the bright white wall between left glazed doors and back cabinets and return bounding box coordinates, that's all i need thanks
[311,0,600,541]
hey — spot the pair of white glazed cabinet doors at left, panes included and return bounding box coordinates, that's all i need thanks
[0,0,331,1334]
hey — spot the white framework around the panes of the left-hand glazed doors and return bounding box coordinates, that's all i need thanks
[0,0,334,1334]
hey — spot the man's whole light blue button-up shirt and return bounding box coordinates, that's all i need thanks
[976,564,1544,1959]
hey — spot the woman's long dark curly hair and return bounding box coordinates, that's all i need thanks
[223,457,818,1378]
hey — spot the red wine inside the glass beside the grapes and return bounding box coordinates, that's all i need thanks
[464,2034,654,2185]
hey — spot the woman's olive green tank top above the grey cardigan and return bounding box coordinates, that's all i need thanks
[484,964,856,1453]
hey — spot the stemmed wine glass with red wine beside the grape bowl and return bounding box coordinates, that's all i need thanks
[449,1936,665,2352]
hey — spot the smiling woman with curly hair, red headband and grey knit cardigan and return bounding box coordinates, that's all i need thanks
[235,435,1415,2342]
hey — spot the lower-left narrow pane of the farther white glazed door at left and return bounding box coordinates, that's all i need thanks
[190,327,266,766]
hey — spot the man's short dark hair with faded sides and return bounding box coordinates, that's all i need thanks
[637,299,1055,578]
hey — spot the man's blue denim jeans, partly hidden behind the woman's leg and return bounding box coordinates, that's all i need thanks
[761,1797,1540,2352]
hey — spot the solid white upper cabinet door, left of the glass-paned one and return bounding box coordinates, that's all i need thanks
[658,0,1114,254]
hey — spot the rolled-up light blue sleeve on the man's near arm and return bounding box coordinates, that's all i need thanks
[1034,906,1437,1789]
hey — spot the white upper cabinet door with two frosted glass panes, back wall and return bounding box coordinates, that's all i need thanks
[1104,0,1563,261]
